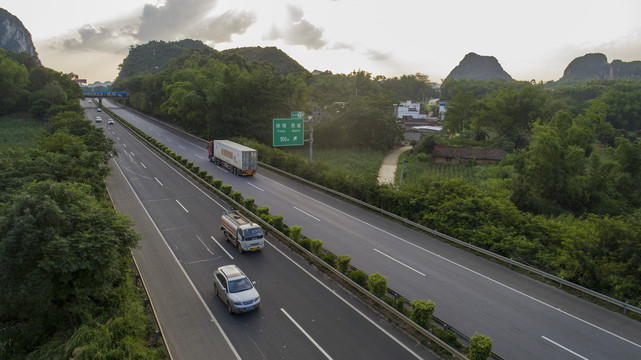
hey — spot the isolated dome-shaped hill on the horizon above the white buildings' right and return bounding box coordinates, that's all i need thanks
[447,53,513,80]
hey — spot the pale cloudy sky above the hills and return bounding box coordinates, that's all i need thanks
[0,0,641,83]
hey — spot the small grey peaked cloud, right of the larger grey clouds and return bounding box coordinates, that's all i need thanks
[264,5,327,50]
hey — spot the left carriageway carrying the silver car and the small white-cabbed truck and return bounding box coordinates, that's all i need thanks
[83,102,434,359]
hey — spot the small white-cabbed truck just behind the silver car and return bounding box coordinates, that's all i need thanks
[220,210,265,254]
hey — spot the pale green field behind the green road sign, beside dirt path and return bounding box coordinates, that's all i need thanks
[284,146,383,176]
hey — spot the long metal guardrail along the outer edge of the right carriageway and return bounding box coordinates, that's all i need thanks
[259,162,641,315]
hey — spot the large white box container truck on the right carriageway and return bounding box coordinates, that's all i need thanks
[208,140,258,176]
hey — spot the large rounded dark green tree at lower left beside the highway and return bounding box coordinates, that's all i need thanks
[0,180,138,349]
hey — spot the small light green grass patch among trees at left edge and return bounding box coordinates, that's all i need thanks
[0,114,43,151]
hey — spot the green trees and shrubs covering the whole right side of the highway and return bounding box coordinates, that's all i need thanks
[114,42,641,306]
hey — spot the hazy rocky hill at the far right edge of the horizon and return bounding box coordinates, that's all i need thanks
[546,53,641,86]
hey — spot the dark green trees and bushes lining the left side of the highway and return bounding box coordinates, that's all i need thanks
[0,50,167,360]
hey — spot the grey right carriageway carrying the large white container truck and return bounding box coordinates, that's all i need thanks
[100,99,641,359]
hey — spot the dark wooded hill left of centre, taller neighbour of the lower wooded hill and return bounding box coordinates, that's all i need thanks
[118,39,217,79]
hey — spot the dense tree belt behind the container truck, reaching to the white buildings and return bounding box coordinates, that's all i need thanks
[113,43,435,150]
